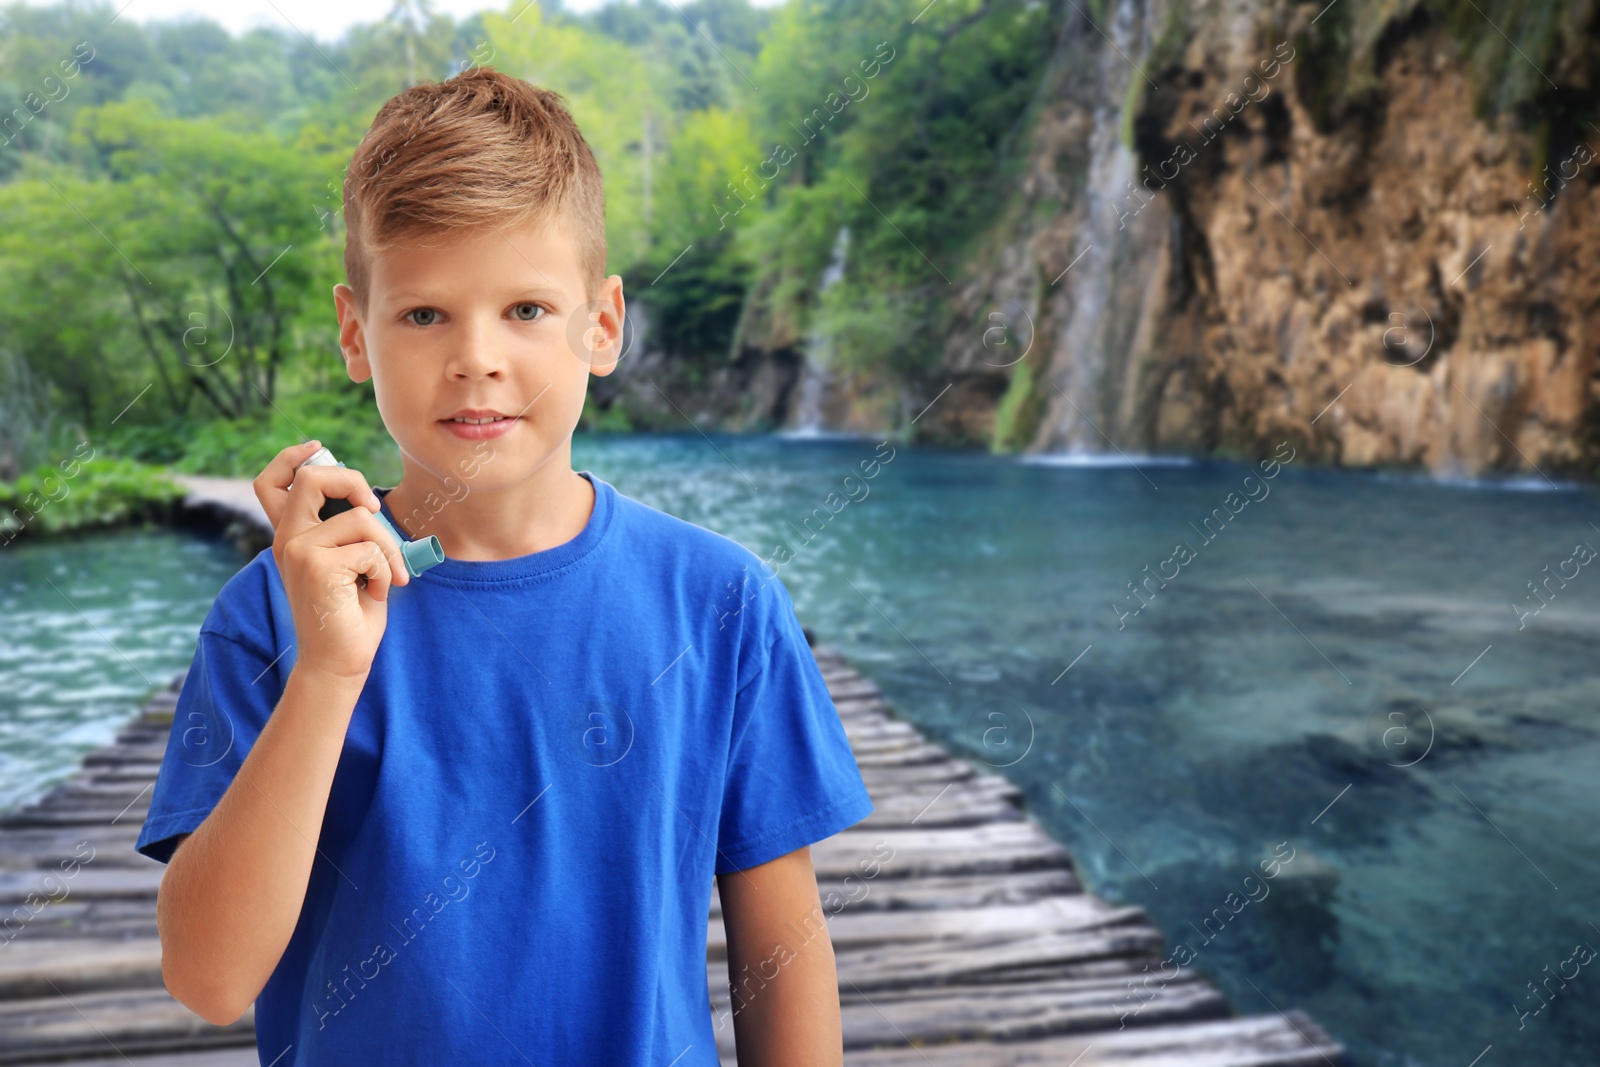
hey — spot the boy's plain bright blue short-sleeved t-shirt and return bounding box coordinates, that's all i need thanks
[136,470,872,1067]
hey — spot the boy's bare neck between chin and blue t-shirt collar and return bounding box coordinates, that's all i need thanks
[384,454,595,560]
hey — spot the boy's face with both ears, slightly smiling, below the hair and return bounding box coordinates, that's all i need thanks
[333,219,624,490]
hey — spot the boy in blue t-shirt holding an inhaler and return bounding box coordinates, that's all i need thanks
[138,67,872,1067]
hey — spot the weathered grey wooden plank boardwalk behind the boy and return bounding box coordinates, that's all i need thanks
[0,485,1346,1067]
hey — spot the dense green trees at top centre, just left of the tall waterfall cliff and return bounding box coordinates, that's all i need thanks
[739,0,1056,363]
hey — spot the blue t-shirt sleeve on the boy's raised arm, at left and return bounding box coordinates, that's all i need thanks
[134,627,283,864]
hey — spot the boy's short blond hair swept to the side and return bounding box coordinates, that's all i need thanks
[344,67,605,312]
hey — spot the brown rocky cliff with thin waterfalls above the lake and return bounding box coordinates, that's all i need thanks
[598,0,1600,478]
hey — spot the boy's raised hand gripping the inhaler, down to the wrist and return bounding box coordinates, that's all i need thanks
[251,442,411,678]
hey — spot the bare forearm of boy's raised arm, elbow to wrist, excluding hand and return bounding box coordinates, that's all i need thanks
[155,665,363,1025]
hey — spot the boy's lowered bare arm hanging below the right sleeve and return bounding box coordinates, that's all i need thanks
[717,846,845,1067]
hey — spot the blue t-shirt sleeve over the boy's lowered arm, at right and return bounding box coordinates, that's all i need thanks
[715,593,872,873]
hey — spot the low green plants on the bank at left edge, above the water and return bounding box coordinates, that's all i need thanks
[0,454,184,541]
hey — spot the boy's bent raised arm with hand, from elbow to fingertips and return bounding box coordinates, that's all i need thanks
[155,442,411,1025]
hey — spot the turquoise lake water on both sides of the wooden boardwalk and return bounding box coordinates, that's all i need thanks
[0,434,1600,1067]
